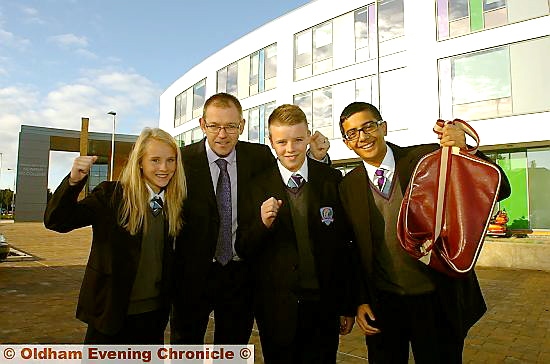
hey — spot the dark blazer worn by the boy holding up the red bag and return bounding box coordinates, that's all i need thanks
[340,143,510,337]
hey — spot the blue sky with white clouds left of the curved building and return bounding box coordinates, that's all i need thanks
[0,0,308,190]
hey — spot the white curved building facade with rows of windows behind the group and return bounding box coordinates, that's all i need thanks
[159,0,550,230]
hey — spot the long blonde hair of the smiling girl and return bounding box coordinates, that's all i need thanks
[118,128,187,237]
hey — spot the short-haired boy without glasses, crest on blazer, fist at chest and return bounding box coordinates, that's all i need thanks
[236,104,355,364]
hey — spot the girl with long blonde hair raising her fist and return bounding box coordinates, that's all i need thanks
[44,128,186,344]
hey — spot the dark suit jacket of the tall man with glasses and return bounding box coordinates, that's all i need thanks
[176,139,275,308]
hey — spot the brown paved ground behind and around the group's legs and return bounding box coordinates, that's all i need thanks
[0,221,550,364]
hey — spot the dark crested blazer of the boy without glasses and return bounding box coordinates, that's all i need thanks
[236,159,356,346]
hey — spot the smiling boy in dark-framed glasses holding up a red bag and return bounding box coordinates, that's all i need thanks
[340,102,510,363]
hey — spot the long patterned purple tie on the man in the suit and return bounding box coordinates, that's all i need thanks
[214,158,233,265]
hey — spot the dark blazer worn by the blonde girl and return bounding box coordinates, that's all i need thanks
[44,176,173,335]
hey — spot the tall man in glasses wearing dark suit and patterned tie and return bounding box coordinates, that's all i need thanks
[174,93,328,344]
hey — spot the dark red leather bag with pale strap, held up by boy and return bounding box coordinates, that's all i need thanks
[397,119,501,277]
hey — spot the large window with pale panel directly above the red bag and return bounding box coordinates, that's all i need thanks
[439,37,550,120]
